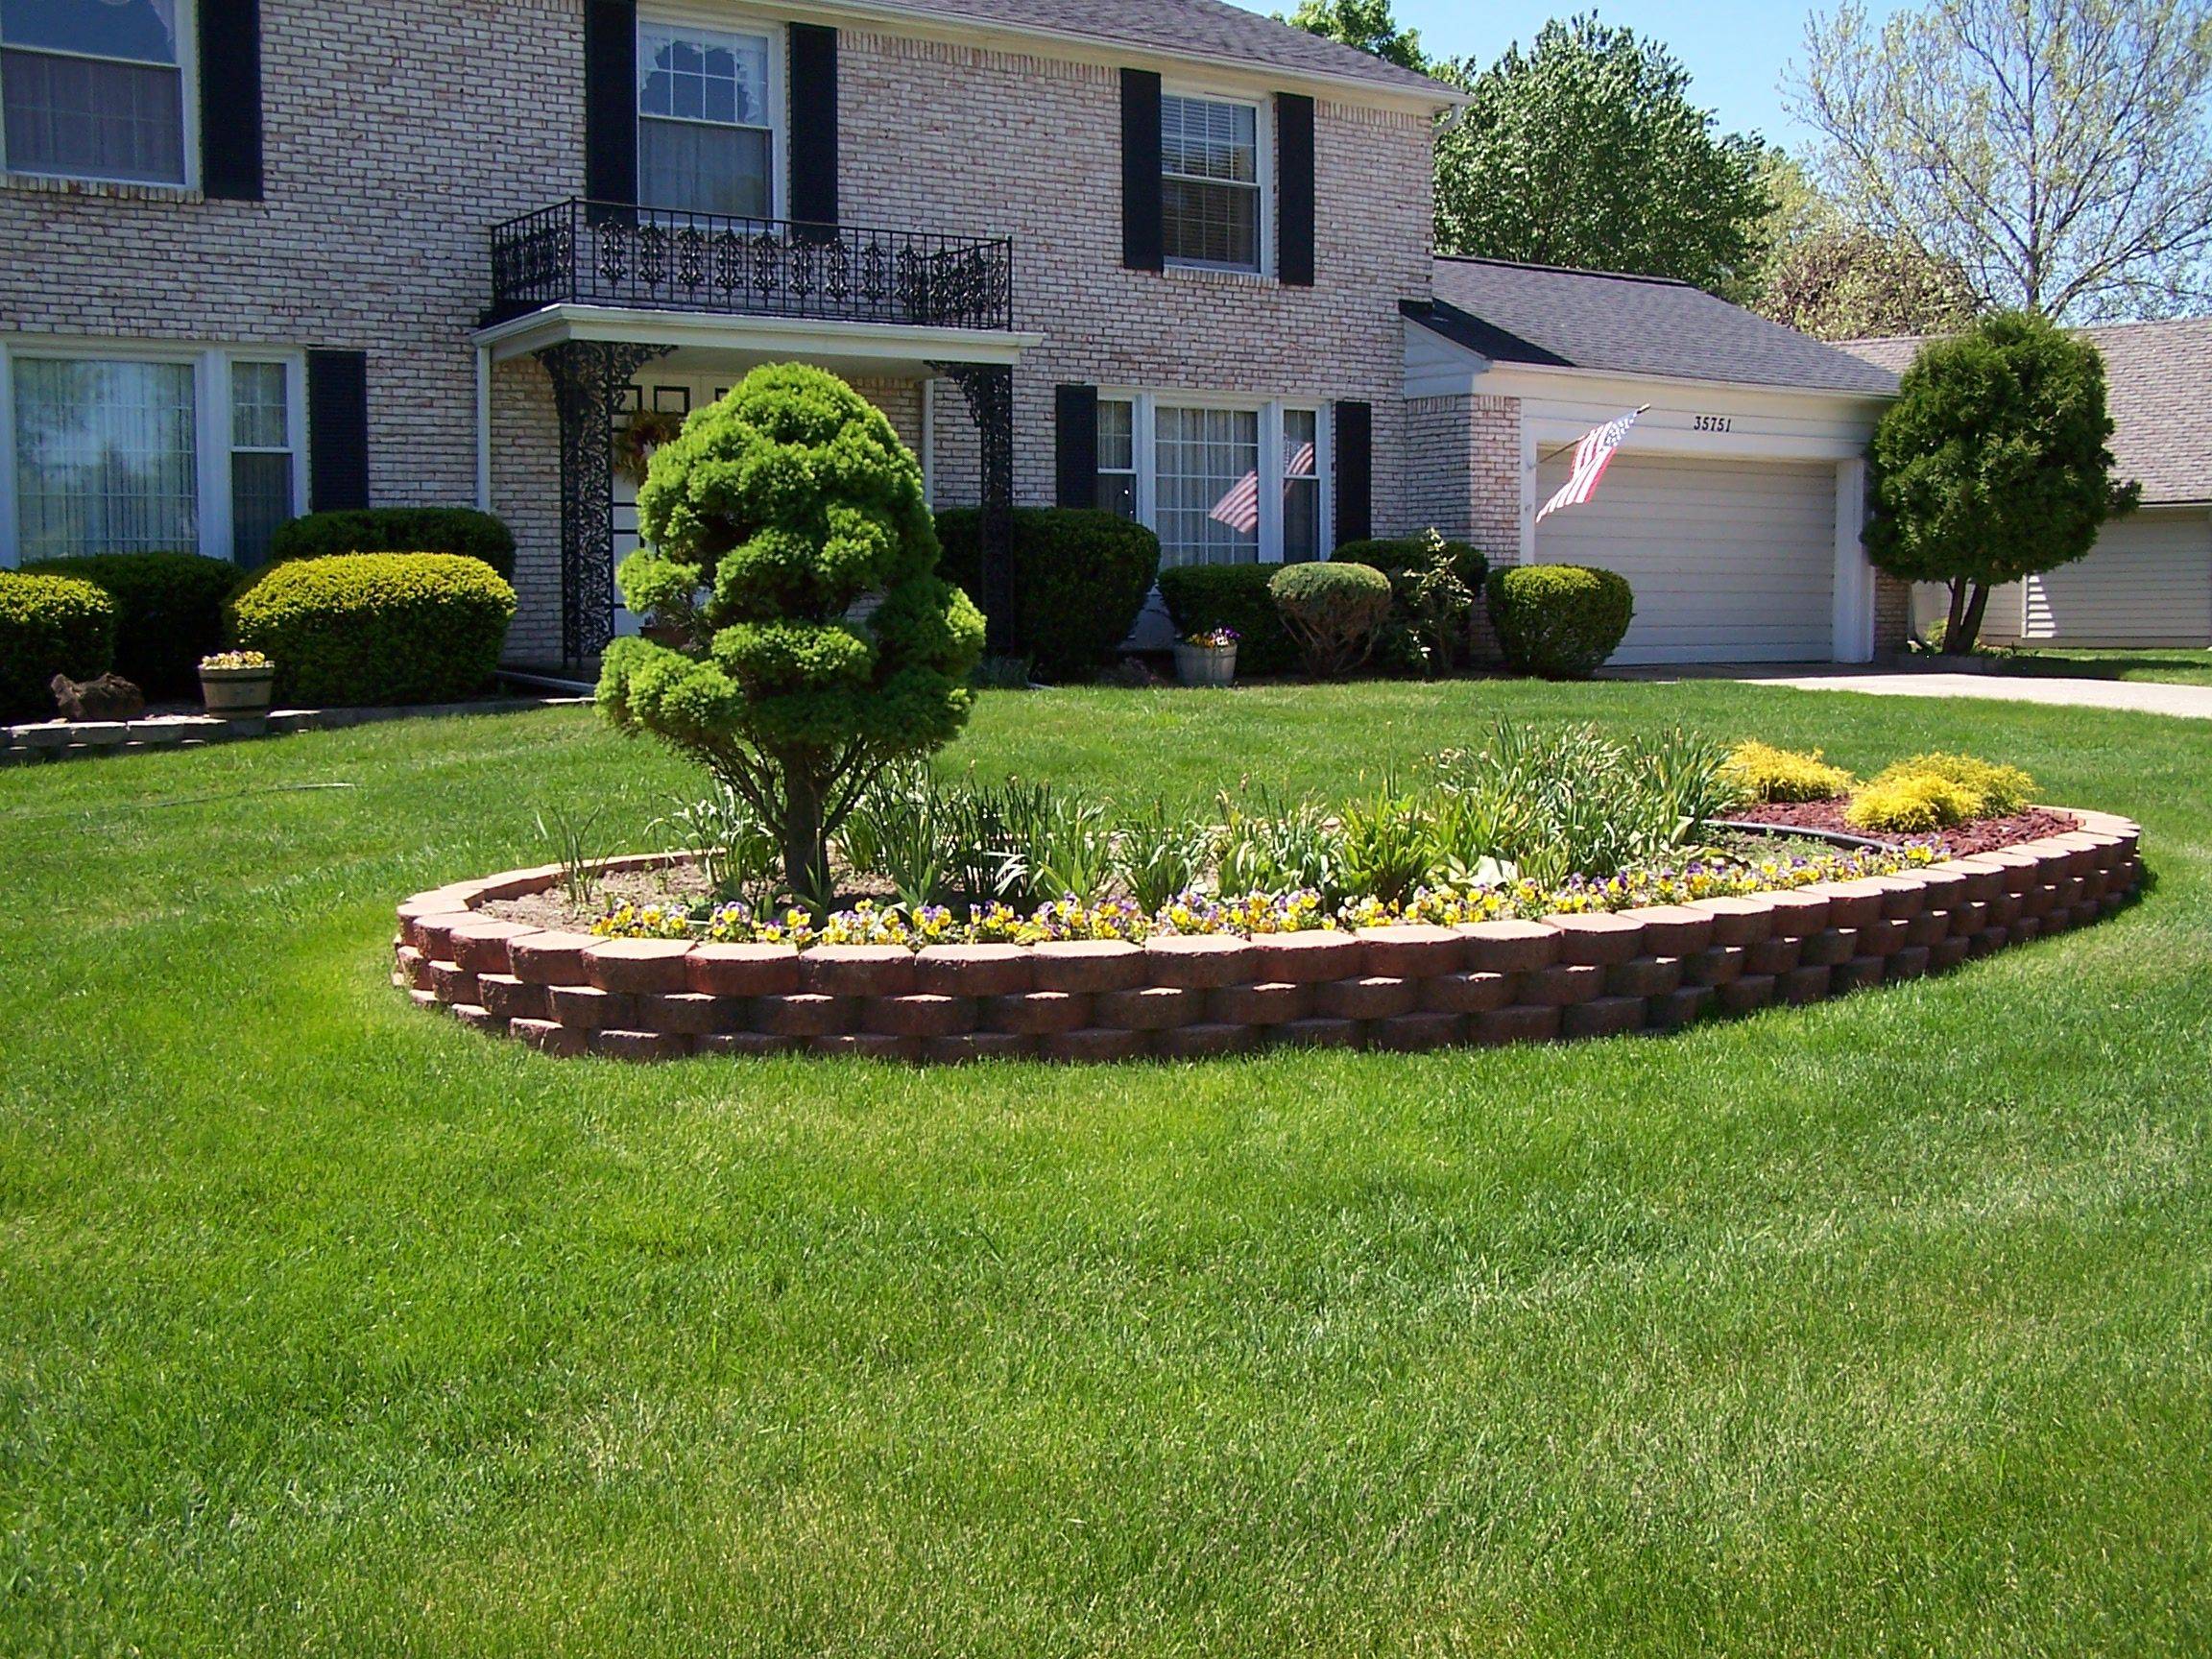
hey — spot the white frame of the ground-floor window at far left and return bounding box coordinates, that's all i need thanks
[0,334,307,568]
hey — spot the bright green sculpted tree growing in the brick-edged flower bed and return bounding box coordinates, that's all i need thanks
[599,363,982,898]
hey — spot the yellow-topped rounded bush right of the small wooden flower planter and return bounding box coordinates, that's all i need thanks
[230,553,516,708]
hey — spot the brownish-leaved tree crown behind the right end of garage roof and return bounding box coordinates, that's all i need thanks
[1754,226,1978,341]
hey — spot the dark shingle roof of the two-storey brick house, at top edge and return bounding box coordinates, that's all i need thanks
[823,0,1464,104]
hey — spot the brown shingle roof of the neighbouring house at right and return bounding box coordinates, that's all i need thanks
[1845,319,2212,502]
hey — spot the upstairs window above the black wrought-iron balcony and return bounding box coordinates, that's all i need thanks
[637,24,777,219]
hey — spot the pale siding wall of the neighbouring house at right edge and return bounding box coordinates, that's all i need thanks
[2026,511,2212,646]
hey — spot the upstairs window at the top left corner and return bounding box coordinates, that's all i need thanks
[0,0,186,183]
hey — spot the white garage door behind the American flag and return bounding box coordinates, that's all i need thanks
[1535,456,1836,663]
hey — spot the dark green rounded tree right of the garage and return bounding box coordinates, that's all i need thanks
[1864,312,2141,653]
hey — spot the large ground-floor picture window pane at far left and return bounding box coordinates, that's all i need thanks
[15,358,199,560]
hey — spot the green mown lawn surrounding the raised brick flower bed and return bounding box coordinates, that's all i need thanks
[0,684,2212,1659]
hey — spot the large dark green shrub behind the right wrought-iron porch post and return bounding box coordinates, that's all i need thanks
[938,507,1159,679]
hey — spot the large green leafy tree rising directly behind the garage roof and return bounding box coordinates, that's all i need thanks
[1435,15,1772,292]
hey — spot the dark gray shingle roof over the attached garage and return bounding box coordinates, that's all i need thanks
[1409,256,1898,398]
